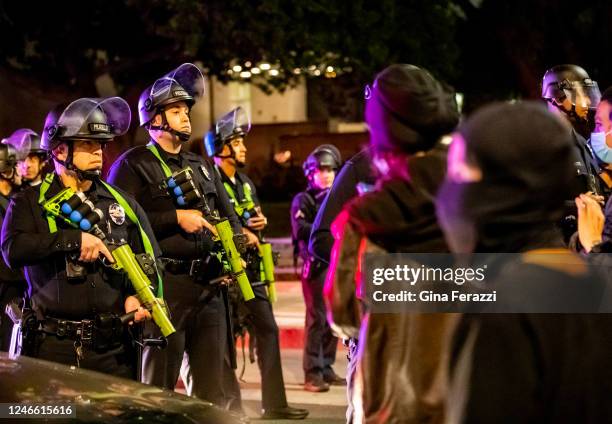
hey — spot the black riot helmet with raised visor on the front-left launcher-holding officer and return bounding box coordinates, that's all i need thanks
[41,97,132,179]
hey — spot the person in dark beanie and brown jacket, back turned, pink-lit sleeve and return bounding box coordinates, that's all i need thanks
[325,65,459,423]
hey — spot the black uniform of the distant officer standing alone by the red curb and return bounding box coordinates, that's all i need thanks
[291,188,338,381]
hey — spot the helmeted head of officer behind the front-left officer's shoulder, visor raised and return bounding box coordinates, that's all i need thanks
[7,128,47,187]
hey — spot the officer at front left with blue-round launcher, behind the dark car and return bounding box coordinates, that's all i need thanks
[2,97,156,378]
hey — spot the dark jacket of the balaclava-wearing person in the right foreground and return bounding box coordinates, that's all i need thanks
[448,260,612,423]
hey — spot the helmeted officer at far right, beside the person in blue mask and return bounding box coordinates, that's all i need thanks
[542,64,608,242]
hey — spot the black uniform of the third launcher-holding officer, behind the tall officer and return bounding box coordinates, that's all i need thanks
[215,166,287,410]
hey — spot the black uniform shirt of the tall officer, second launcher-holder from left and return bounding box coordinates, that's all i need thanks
[108,142,240,260]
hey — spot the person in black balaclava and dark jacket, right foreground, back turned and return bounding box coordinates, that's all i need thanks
[437,102,612,423]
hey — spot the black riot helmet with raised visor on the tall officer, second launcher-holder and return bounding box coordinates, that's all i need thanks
[138,63,204,141]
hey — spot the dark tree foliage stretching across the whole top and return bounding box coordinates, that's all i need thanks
[0,0,612,116]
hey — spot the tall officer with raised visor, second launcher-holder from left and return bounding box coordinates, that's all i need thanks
[109,63,241,409]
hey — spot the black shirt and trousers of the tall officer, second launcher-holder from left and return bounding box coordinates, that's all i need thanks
[108,142,240,406]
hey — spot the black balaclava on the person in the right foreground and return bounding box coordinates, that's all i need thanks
[437,102,573,253]
